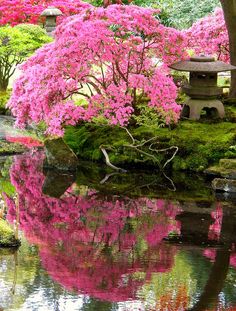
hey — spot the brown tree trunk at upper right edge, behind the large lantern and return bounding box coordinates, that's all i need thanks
[220,0,236,98]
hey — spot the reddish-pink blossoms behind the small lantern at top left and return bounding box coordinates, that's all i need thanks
[0,0,90,26]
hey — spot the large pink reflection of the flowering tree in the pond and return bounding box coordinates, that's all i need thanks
[7,154,183,301]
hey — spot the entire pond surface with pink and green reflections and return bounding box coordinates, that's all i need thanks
[0,152,236,311]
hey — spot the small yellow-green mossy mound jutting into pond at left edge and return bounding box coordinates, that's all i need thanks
[0,219,20,247]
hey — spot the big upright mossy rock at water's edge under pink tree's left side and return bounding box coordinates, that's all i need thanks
[44,138,78,170]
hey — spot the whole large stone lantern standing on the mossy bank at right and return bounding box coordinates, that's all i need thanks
[170,56,236,120]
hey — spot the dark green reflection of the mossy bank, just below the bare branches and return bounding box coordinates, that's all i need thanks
[76,161,214,202]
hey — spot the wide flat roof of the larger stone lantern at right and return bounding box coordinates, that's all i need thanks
[169,56,236,73]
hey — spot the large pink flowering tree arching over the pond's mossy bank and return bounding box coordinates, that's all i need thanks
[9,5,186,136]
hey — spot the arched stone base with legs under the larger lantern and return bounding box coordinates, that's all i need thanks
[181,98,225,120]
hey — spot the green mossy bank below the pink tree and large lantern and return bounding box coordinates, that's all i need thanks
[65,121,236,172]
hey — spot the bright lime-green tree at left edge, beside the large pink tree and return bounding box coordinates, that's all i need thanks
[0,24,52,92]
